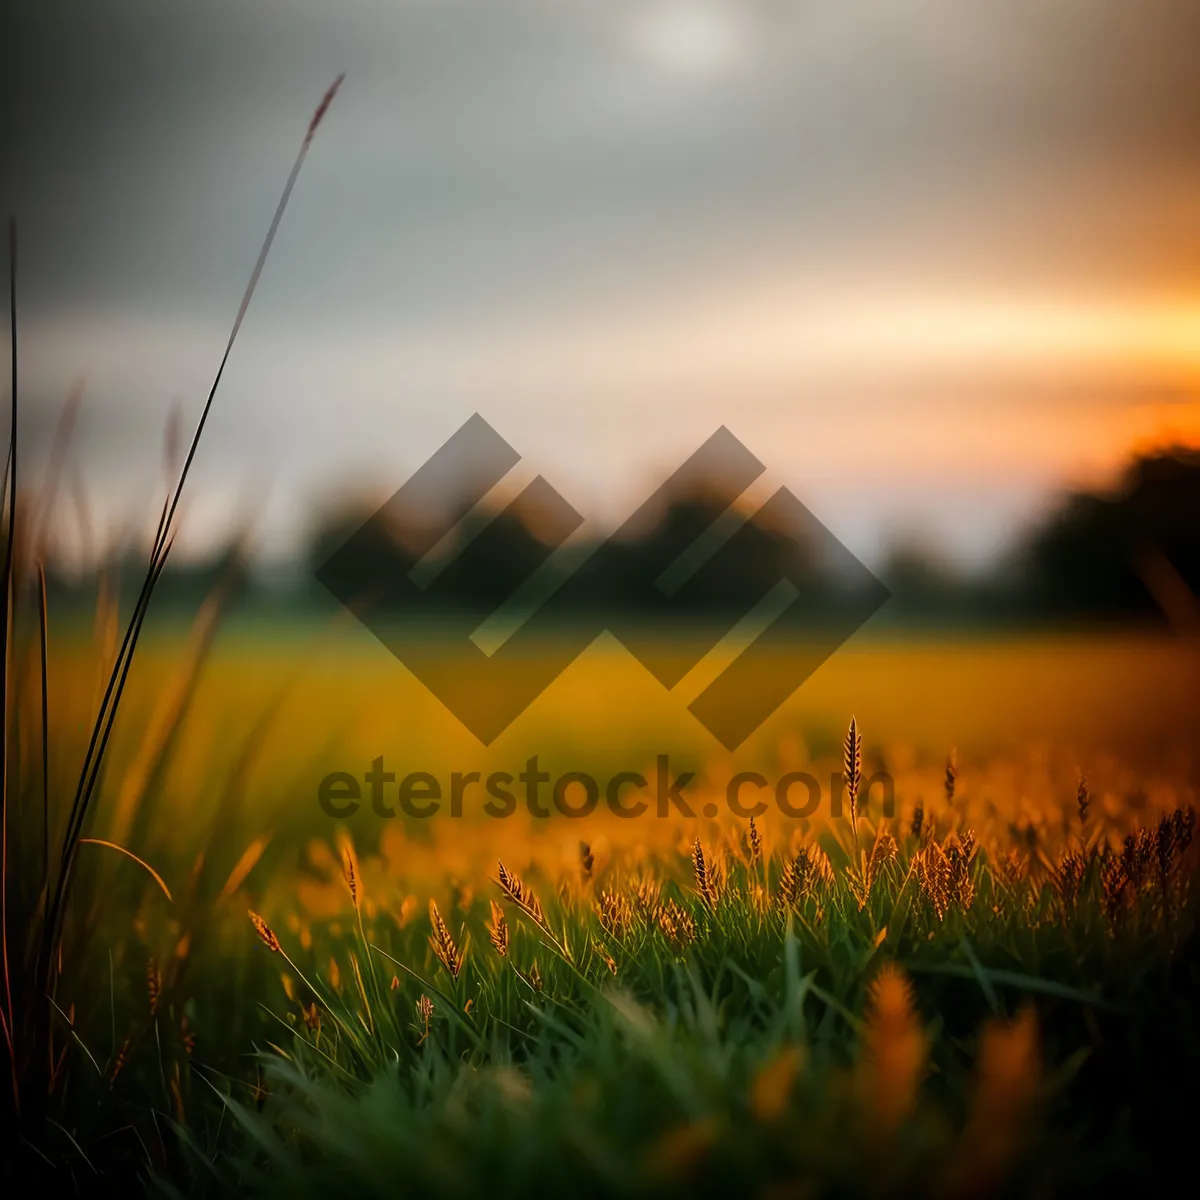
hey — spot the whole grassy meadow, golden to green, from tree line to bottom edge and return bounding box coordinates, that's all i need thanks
[8,606,1200,1195]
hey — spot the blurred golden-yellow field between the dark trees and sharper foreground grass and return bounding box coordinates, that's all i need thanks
[37,623,1200,898]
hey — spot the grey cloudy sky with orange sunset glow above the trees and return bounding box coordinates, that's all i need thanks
[7,0,1200,565]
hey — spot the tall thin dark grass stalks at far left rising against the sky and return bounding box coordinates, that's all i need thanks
[0,76,342,1190]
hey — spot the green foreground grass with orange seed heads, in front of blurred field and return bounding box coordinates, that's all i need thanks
[2,641,1200,1195]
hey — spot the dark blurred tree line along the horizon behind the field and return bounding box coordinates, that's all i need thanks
[47,448,1200,629]
